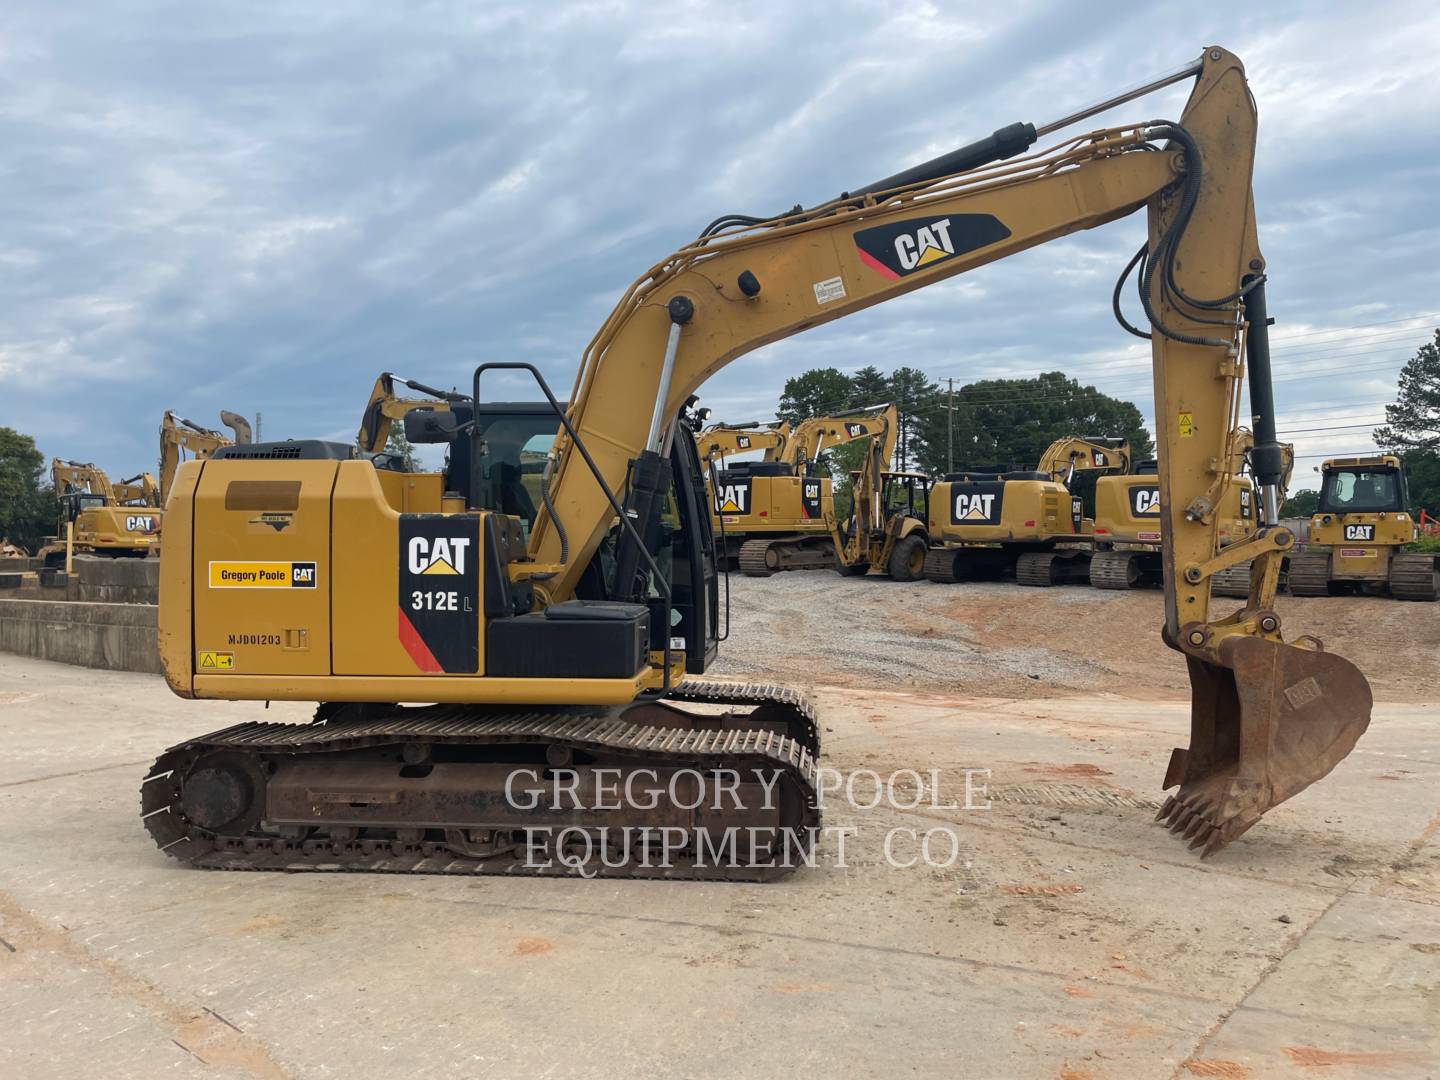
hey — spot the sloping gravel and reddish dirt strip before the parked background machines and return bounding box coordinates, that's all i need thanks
[713,570,1440,701]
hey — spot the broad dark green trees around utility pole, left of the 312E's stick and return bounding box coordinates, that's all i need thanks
[914,372,1155,472]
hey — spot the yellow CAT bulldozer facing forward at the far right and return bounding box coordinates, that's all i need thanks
[1289,454,1440,600]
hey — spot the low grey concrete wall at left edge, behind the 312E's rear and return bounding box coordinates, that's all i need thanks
[0,601,160,674]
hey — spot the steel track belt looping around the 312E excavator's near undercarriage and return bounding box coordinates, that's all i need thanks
[149,705,819,881]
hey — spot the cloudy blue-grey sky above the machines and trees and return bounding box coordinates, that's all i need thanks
[0,0,1440,482]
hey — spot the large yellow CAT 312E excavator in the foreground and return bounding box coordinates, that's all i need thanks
[141,48,1371,881]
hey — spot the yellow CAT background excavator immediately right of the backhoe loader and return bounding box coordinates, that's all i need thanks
[924,436,1130,586]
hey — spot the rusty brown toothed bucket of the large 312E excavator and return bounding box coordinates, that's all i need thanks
[1156,636,1371,858]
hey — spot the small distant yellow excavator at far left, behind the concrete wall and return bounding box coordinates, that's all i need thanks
[37,458,164,569]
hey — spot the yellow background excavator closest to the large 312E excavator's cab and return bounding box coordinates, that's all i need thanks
[710,405,899,577]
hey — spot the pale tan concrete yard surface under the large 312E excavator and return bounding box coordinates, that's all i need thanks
[0,655,1440,1080]
